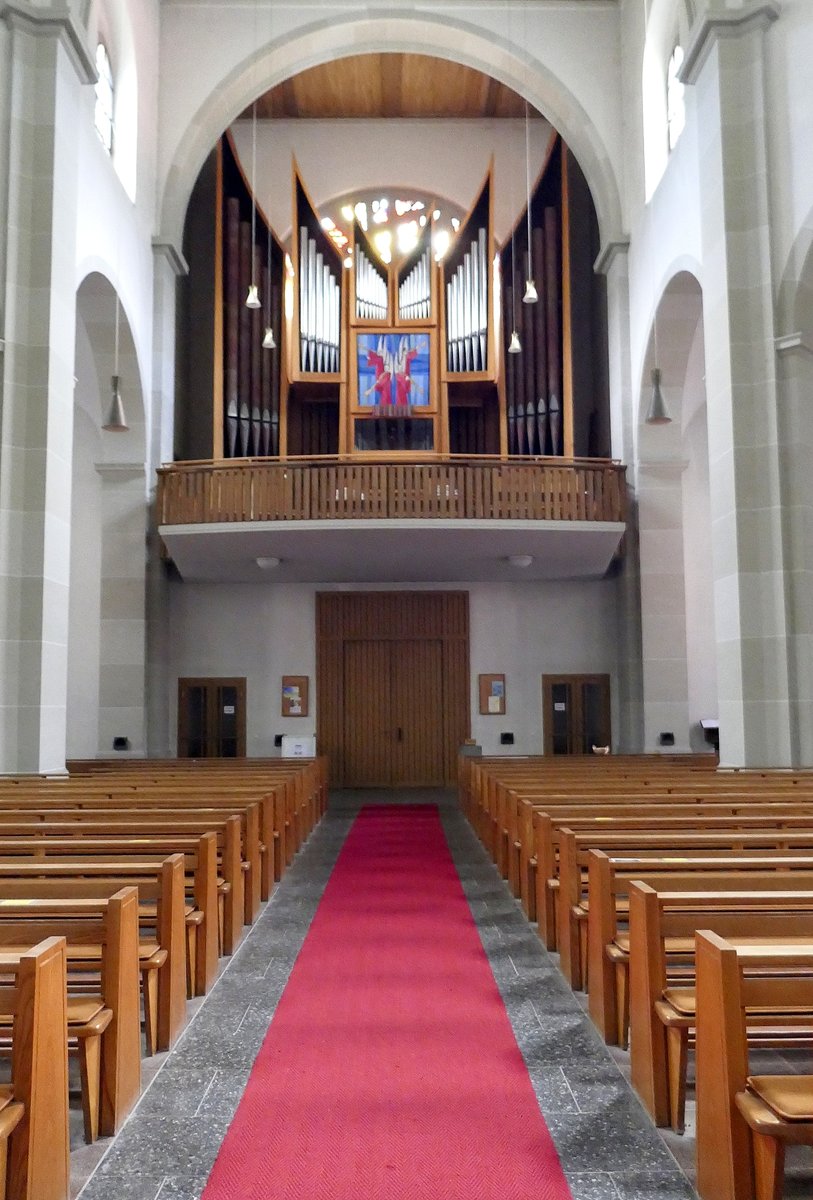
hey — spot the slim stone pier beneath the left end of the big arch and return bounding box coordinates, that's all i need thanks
[146,240,188,757]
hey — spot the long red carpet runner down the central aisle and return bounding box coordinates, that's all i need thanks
[204,805,571,1200]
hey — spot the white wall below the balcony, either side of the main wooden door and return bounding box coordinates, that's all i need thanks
[168,581,615,756]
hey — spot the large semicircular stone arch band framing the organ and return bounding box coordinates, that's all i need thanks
[159,14,624,255]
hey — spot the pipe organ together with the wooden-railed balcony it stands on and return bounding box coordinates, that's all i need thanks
[157,134,626,582]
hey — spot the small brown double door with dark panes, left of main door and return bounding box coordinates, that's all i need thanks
[177,678,246,758]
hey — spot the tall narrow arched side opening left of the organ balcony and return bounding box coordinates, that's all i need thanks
[67,271,146,757]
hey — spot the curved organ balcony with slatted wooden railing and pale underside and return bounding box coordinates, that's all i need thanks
[158,458,625,582]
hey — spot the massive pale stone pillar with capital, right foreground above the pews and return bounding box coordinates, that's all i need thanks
[682,0,793,767]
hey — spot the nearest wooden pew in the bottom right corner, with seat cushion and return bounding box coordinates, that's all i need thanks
[695,930,813,1200]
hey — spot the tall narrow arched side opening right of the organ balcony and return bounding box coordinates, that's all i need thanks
[636,268,717,751]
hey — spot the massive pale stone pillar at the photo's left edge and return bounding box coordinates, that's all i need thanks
[0,0,95,773]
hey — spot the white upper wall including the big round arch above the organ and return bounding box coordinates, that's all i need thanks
[158,0,622,250]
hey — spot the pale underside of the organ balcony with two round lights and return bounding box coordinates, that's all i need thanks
[159,517,625,583]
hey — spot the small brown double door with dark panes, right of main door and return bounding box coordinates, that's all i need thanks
[542,674,612,755]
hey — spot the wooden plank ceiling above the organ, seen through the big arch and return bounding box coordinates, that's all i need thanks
[243,53,538,120]
